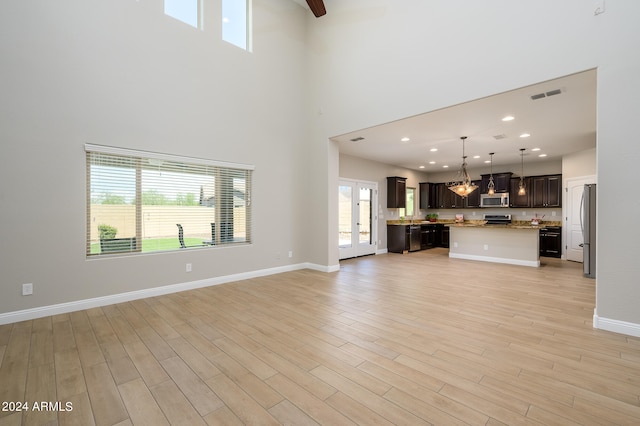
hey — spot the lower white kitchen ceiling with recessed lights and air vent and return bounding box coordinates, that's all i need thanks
[332,70,596,173]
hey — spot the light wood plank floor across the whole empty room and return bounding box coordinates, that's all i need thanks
[0,249,640,425]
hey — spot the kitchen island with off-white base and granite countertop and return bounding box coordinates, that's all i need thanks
[445,223,540,267]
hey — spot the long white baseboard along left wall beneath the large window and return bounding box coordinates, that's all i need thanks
[0,263,340,325]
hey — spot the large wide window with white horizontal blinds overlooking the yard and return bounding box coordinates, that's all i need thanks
[85,145,253,256]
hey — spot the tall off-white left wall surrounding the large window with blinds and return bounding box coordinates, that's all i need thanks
[0,0,310,314]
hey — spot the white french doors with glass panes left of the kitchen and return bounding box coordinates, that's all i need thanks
[338,179,378,259]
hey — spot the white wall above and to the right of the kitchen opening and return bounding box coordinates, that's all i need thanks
[309,0,640,329]
